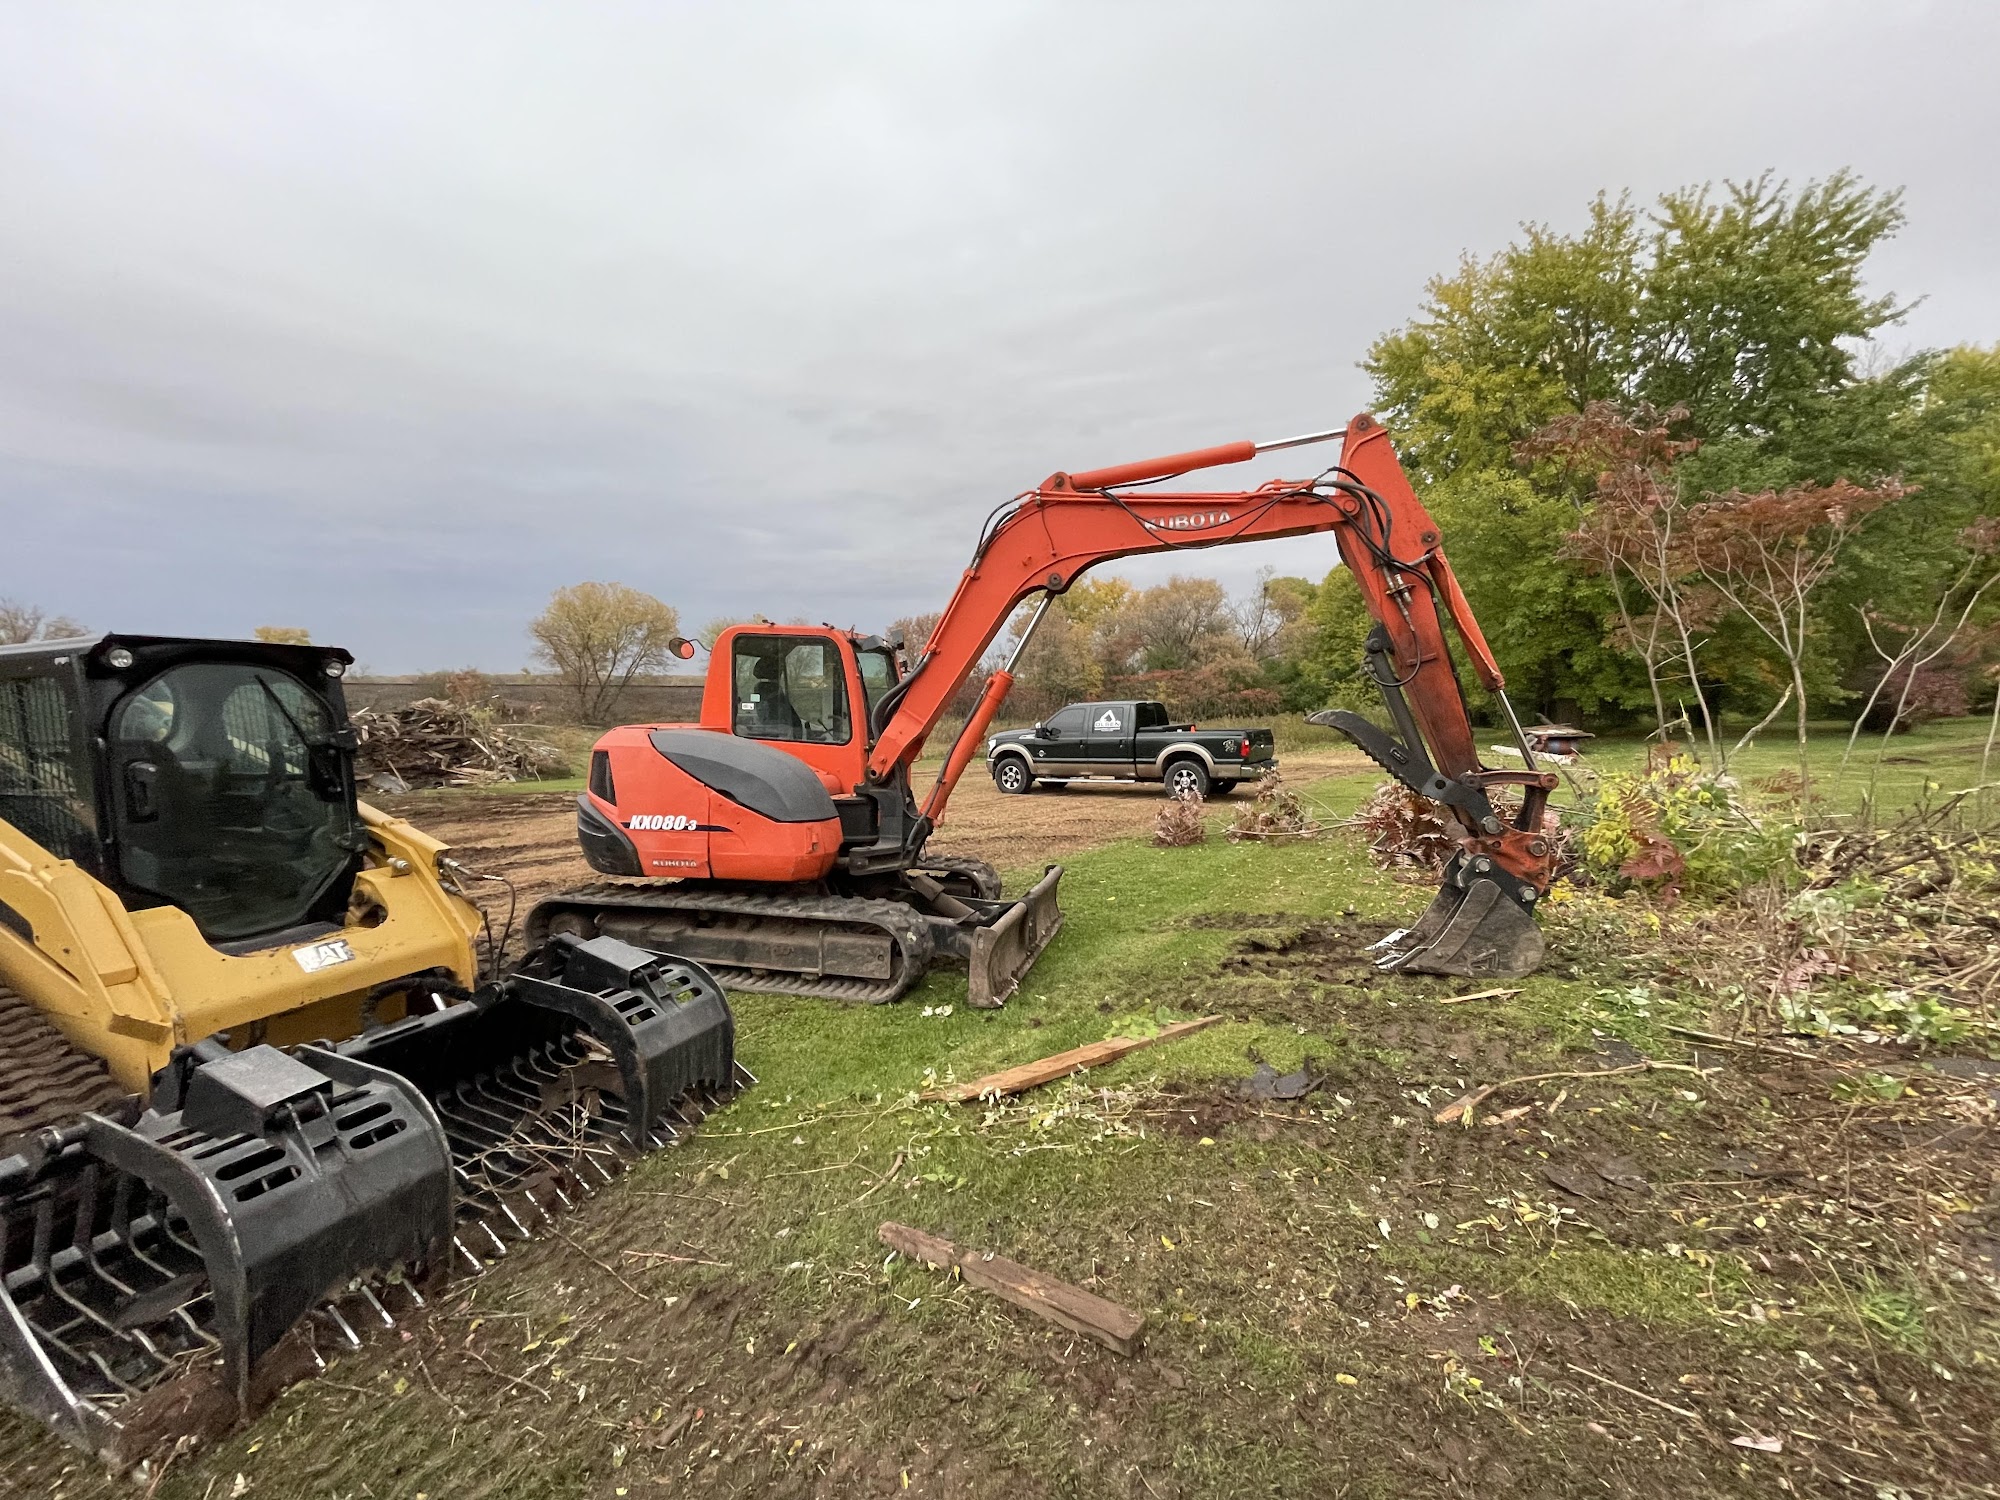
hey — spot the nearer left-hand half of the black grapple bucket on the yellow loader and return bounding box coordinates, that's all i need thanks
[0,1046,452,1462]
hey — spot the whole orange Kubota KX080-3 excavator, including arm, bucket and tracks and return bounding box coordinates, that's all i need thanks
[528,416,1556,1006]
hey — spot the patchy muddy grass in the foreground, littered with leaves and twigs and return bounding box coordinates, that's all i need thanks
[35,768,2000,1500]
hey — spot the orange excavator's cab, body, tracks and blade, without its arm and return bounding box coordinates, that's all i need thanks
[556,626,1062,1006]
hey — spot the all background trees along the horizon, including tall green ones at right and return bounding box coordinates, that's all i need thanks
[11,172,2000,776]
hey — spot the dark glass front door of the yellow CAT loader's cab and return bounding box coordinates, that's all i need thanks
[110,662,360,942]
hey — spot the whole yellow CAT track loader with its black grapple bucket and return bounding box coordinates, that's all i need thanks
[0,634,742,1462]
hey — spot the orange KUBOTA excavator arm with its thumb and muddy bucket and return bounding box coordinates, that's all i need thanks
[868,414,1556,976]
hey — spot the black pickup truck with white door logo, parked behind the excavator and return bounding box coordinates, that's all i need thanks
[986,700,1278,796]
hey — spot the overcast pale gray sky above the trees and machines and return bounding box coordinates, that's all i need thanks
[0,0,2000,670]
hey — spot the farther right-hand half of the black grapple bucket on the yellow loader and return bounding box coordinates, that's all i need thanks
[336,934,752,1266]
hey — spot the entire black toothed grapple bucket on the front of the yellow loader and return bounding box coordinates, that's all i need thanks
[0,938,754,1464]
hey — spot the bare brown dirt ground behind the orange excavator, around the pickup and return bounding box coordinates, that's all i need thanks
[376,750,1368,902]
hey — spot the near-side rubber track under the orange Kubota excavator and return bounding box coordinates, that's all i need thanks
[526,880,938,1004]
